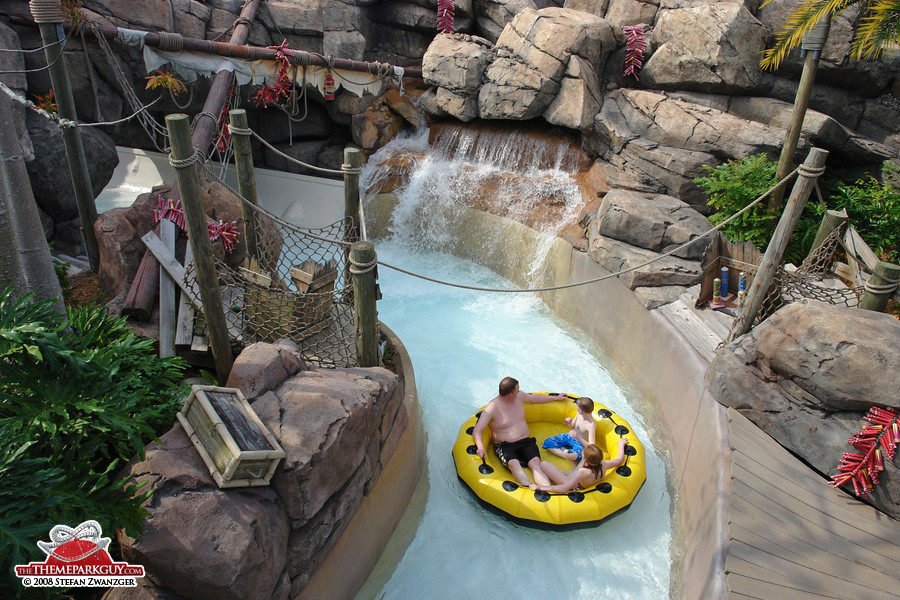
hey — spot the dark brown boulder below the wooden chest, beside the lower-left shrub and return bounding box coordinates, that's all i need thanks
[118,424,290,600]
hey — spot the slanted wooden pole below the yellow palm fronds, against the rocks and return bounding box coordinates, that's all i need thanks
[768,15,831,214]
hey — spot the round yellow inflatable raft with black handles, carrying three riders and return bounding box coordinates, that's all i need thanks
[453,392,647,529]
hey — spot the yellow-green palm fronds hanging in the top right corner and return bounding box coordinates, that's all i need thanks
[760,0,900,70]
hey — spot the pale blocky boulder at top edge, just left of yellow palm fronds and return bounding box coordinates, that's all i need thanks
[641,2,767,94]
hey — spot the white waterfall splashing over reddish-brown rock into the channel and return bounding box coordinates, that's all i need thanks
[361,124,590,281]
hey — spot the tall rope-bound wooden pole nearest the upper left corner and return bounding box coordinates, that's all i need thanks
[29,0,100,272]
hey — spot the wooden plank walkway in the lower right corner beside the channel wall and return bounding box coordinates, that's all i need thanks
[725,408,900,600]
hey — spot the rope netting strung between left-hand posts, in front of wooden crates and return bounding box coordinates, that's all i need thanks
[185,166,356,367]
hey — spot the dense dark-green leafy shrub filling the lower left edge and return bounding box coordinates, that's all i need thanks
[0,288,186,597]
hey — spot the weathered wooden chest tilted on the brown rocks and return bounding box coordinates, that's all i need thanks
[178,385,284,488]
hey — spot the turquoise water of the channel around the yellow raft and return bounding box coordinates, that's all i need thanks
[359,240,672,600]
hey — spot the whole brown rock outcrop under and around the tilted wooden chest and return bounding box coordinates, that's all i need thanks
[105,343,407,600]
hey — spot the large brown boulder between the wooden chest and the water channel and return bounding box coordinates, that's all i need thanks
[253,368,408,597]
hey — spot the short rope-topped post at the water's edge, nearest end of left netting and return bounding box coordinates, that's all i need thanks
[350,242,378,367]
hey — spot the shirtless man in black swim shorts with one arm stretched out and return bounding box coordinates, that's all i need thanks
[472,377,565,487]
